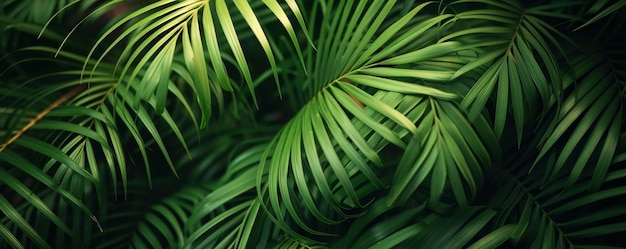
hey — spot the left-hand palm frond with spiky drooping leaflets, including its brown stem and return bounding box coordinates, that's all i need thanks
[2,47,192,189]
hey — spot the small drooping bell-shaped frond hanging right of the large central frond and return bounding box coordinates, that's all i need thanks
[388,98,499,206]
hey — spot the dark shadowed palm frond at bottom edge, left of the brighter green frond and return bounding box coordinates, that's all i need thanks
[92,182,210,248]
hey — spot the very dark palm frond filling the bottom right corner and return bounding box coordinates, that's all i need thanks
[491,164,626,248]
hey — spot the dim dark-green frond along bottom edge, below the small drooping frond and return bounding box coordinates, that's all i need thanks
[332,201,515,248]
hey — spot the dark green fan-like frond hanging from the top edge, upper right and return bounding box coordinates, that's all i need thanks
[441,0,562,144]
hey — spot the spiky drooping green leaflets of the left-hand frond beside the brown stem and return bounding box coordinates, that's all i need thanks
[1,44,192,190]
